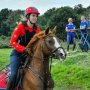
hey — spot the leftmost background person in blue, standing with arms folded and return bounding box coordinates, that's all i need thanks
[66,18,76,51]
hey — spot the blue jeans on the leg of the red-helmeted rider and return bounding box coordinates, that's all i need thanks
[10,50,22,81]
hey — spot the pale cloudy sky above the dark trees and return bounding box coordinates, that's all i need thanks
[0,0,90,14]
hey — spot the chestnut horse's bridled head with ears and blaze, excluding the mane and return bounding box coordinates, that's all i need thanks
[40,27,66,60]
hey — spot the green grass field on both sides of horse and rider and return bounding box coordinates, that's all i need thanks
[0,49,90,90]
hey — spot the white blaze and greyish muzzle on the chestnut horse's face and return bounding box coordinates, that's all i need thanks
[53,37,66,60]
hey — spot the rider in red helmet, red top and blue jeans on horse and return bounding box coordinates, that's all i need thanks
[7,7,41,90]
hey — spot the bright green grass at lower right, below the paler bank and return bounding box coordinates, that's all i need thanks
[52,65,90,90]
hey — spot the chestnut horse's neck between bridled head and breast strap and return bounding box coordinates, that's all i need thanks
[31,39,50,75]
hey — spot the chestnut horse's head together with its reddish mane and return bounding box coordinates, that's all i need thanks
[27,27,66,60]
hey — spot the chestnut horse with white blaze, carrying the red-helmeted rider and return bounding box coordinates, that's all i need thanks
[22,27,66,90]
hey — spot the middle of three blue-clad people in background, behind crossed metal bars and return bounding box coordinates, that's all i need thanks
[79,16,88,52]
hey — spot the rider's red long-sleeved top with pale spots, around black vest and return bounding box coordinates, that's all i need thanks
[10,24,41,53]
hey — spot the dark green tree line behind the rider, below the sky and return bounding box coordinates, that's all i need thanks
[0,4,90,40]
